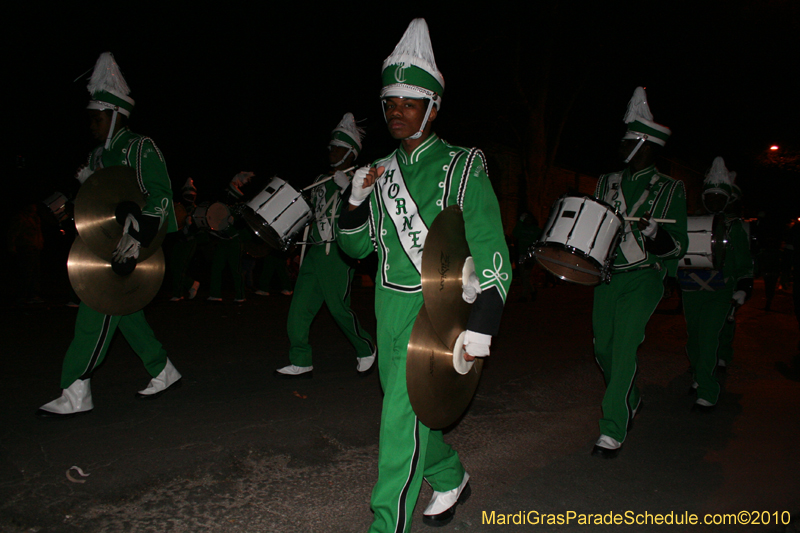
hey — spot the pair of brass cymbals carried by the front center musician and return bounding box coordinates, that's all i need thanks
[406,206,483,429]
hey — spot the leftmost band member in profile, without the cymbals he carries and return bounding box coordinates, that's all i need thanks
[36,52,181,417]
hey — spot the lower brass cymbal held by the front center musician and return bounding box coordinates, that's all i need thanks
[406,304,483,429]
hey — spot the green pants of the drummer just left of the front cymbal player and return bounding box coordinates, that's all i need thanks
[286,243,375,366]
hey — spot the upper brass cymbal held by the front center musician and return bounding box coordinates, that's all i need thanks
[421,205,471,346]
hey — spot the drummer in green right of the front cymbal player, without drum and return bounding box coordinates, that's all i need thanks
[592,87,689,458]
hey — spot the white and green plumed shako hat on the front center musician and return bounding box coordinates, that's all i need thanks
[381,18,444,139]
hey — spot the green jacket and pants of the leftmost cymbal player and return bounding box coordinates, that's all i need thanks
[61,128,178,389]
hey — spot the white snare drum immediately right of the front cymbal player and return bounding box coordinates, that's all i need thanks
[531,196,624,285]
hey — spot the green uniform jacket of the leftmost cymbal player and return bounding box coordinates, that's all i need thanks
[89,127,178,237]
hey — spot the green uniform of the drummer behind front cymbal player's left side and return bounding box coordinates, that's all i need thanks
[286,172,375,367]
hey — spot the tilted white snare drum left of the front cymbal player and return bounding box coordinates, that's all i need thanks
[242,177,313,251]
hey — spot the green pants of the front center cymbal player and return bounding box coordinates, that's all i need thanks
[369,289,464,533]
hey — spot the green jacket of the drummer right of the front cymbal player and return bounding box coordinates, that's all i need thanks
[595,166,689,276]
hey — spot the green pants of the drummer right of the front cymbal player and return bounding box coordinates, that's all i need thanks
[592,268,666,442]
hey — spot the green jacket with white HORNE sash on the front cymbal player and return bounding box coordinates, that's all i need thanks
[337,134,511,335]
